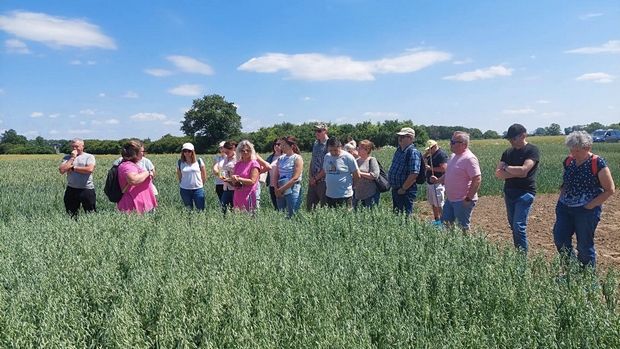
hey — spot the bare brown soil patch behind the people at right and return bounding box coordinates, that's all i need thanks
[416,193,620,270]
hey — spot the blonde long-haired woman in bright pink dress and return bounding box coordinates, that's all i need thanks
[231,139,260,213]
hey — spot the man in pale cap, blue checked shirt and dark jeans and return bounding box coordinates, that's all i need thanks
[388,127,422,215]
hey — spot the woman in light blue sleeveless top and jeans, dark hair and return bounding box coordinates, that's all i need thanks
[274,136,304,218]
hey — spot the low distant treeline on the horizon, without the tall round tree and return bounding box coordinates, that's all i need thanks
[0,120,619,154]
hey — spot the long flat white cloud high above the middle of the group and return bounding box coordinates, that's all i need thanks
[237,51,451,81]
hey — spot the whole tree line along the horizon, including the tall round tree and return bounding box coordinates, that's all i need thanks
[0,94,620,154]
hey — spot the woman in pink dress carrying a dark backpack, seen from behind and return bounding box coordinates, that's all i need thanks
[116,140,157,215]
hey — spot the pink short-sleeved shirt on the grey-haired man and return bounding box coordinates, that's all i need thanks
[444,149,482,202]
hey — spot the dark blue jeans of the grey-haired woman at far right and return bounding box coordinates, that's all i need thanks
[553,202,602,267]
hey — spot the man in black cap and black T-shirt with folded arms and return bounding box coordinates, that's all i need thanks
[495,124,540,252]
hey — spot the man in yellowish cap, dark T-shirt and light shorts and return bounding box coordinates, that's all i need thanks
[422,139,448,225]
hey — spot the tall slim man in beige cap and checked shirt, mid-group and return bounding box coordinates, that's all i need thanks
[306,122,329,211]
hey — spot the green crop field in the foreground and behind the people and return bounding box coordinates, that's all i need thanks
[0,137,620,348]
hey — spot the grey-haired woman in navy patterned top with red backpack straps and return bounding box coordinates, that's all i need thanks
[553,131,615,268]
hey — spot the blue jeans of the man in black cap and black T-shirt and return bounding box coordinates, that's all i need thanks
[504,188,534,252]
